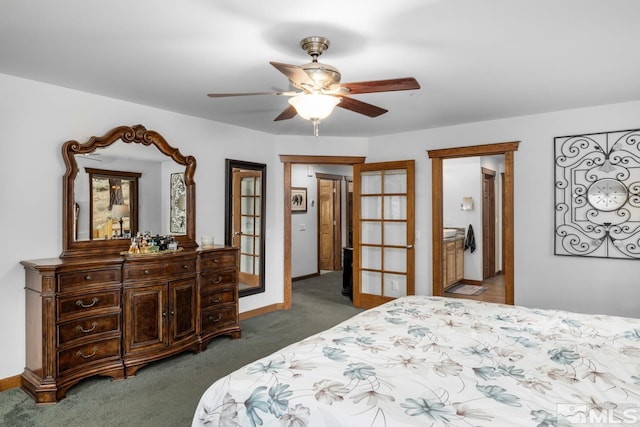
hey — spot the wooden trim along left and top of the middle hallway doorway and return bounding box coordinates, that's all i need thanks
[280,154,365,310]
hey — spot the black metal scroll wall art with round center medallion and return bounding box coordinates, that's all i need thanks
[555,129,640,260]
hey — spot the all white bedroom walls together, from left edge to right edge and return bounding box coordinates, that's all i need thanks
[0,69,640,379]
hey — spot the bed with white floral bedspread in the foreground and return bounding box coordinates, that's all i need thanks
[193,296,640,427]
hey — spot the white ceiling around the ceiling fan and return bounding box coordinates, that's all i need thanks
[0,0,640,137]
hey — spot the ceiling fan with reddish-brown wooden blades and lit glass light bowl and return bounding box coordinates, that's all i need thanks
[208,36,420,136]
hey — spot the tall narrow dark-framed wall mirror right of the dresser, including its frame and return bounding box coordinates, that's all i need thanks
[225,159,267,296]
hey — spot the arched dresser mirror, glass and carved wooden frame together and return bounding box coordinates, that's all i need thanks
[61,125,197,258]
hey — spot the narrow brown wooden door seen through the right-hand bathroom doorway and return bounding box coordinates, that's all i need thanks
[482,168,496,280]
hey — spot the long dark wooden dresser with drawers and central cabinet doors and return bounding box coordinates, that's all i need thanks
[22,246,240,403]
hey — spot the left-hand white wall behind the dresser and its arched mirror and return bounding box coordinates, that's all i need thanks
[0,74,282,378]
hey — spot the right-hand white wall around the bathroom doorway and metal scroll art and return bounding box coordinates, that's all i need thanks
[367,102,640,317]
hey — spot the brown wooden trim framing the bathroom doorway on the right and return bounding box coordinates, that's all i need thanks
[427,141,520,305]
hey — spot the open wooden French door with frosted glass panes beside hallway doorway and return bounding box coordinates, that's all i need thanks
[353,160,415,308]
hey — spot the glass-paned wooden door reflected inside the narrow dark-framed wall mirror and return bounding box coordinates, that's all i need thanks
[232,170,263,286]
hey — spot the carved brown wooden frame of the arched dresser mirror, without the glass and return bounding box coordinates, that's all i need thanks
[60,125,198,258]
